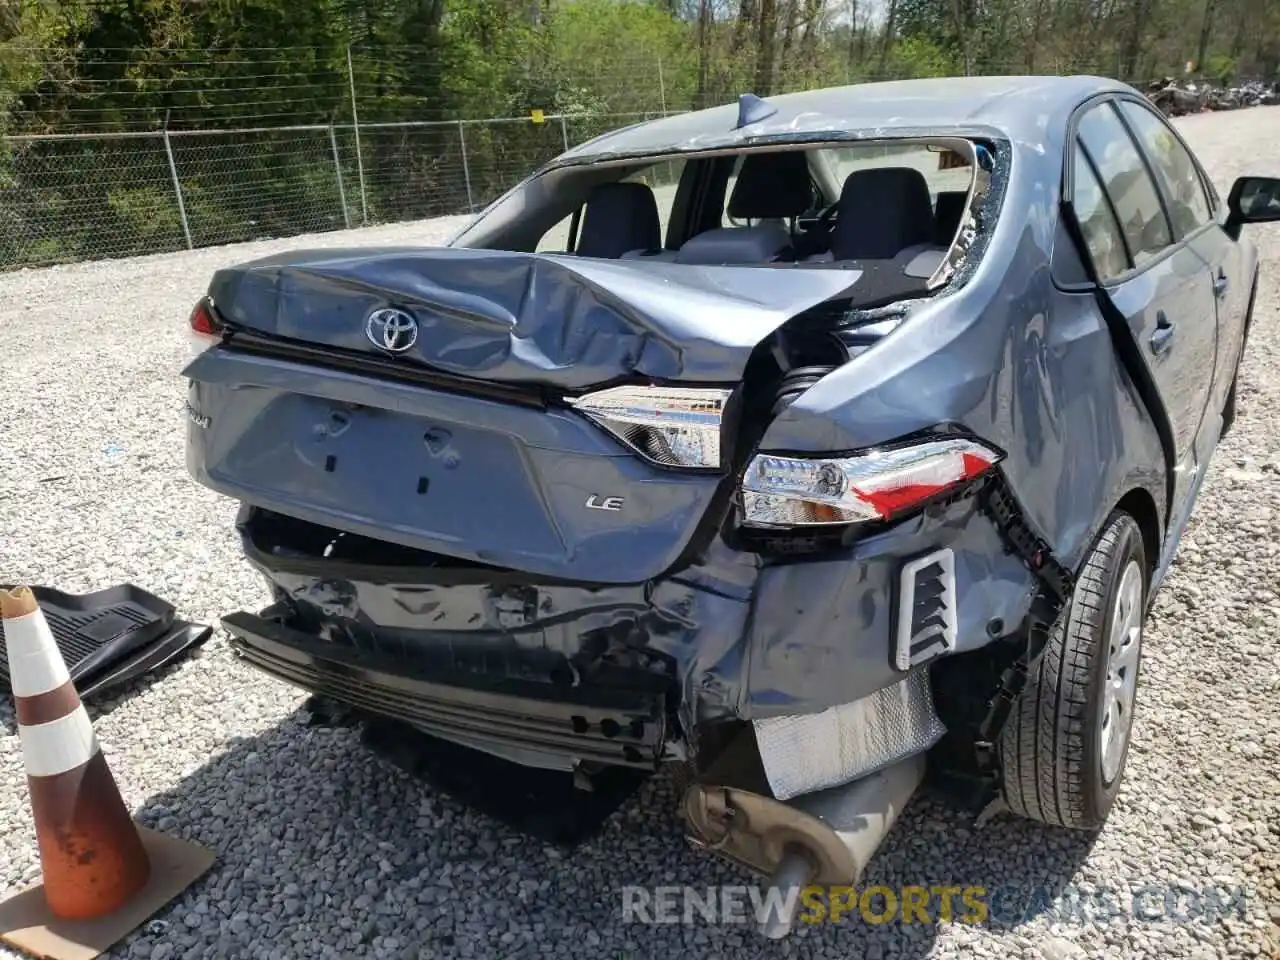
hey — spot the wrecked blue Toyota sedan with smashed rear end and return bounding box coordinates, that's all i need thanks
[184,77,1280,934]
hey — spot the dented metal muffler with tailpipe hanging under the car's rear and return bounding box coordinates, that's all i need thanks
[684,754,924,940]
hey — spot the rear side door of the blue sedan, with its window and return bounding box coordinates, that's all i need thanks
[1075,100,1217,521]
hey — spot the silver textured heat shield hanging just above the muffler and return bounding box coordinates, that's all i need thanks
[753,671,946,800]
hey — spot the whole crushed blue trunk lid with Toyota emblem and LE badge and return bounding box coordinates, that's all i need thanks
[184,248,859,584]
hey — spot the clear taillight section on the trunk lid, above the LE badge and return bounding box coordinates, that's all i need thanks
[570,387,730,467]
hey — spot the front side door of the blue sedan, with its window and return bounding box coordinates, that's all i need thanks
[1119,100,1249,427]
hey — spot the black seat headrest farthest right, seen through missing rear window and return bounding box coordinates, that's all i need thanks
[831,166,933,260]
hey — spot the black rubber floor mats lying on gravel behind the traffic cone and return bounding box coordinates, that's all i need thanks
[0,584,210,696]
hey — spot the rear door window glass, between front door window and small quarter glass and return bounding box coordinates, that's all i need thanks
[1079,104,1172,266]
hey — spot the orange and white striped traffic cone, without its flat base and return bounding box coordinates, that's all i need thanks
[0,586,151,920]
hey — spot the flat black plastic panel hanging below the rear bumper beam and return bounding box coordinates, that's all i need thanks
[361,721,649,847]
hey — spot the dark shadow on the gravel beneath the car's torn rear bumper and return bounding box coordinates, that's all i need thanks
[113,710,1092,960]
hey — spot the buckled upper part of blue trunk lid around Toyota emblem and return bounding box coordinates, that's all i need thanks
[209,247,861,390]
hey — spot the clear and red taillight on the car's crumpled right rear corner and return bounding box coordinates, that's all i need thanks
[742,439,1001,527]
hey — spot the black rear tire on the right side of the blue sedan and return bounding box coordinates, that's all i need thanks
[1000,512,1149,829]
